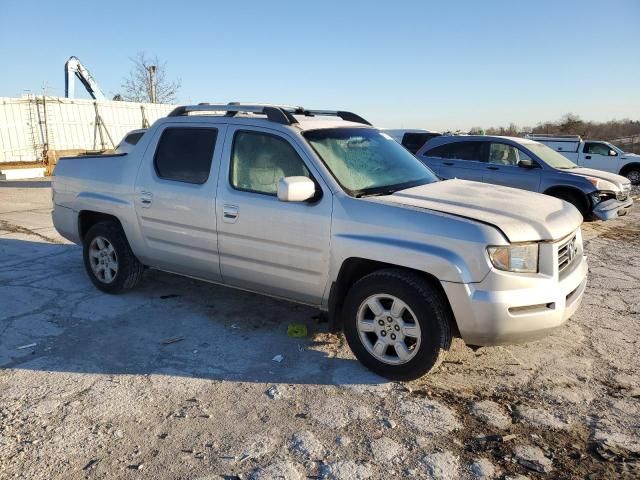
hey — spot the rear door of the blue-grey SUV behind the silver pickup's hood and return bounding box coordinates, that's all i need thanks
[422,141,485,182]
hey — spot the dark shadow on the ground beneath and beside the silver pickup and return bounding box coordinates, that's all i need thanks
[0,237,386,385]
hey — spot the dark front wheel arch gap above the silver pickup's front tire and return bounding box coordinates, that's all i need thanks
[328,257,458,334]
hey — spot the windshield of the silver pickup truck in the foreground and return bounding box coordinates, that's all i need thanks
[304,128,438,197]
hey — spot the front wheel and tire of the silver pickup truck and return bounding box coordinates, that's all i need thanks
[342,268,453,380]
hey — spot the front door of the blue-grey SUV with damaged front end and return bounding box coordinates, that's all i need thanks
[483,142,542,192]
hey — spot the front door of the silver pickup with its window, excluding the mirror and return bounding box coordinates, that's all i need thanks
[216,126,332,305]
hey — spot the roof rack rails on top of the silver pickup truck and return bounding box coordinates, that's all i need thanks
[167,102,371,125]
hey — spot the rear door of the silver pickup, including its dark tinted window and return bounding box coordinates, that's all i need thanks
[134,122,226,281]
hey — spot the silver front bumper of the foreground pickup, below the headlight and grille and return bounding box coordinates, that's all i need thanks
[441,253,588,346]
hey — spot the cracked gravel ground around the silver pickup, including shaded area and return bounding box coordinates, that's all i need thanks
[0,181,640,479]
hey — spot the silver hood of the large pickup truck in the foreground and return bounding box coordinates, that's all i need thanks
[368,179,582,243]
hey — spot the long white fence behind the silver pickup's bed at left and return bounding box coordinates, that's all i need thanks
[0,96,175,164]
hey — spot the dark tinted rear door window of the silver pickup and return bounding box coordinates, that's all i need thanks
[154,127,218,184]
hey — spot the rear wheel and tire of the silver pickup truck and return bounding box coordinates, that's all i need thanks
[82,221,144,293]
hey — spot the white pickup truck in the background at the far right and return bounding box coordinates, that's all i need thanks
[527,134,640,185]
